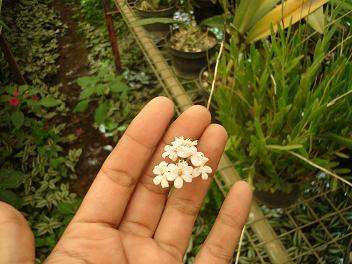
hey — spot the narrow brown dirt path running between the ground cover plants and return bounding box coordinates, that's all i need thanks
[53,0,112,194]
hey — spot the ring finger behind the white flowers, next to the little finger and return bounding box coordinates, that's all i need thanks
[154,124,227,261]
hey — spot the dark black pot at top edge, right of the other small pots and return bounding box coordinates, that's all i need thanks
[193,0,224,24]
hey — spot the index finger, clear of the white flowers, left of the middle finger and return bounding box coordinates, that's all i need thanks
[73,97,174,226]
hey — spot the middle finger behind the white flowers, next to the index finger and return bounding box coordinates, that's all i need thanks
[119,106,211,237]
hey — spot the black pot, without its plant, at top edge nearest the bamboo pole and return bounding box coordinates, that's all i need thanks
[135,1,176,32]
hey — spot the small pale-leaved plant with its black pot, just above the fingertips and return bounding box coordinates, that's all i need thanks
[167,25,217,79]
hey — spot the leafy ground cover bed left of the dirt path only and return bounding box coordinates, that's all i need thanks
[0,1,81,261]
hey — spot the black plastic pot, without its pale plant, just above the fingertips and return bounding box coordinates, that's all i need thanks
[166,31,216,80]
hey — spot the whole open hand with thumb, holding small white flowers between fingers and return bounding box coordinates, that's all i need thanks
[0,97,252,264]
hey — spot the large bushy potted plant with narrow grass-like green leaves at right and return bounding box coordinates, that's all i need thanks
[215,13,352,207]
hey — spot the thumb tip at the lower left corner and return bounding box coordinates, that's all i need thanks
[0,202,35,263]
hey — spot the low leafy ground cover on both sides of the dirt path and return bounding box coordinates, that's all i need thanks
[0,0,160,263]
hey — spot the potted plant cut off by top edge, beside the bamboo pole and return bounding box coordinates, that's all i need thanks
[135,0,176,32]
